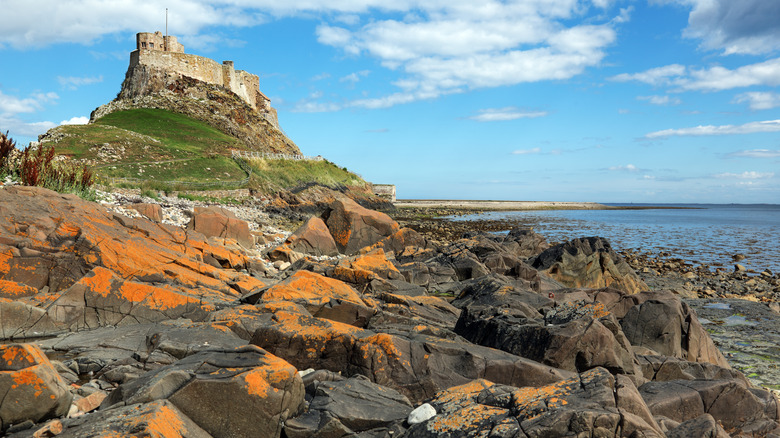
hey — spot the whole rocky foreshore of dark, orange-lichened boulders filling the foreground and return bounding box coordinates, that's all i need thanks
[0,187,780,438]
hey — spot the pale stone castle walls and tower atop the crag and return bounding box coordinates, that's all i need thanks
[130,31,275,113]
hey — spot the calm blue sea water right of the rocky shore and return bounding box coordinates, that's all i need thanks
[452,204,780,273]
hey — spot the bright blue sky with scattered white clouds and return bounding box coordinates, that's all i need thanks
[0,0,780,203]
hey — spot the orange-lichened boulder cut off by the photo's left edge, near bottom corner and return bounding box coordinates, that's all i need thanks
[0,344,73,431]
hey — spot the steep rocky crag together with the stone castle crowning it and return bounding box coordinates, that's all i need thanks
[90,34,301,154]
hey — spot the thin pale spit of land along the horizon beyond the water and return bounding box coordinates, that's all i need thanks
[393,199,697,211]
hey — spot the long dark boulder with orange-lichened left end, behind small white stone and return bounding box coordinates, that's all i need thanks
[251,302,570,402]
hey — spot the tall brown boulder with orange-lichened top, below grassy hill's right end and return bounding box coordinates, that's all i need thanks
[322,198,399,255]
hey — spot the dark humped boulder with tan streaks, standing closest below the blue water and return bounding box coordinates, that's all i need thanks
[530,237,649,294]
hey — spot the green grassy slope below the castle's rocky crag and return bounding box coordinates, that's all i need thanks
[42,109,366,194]
